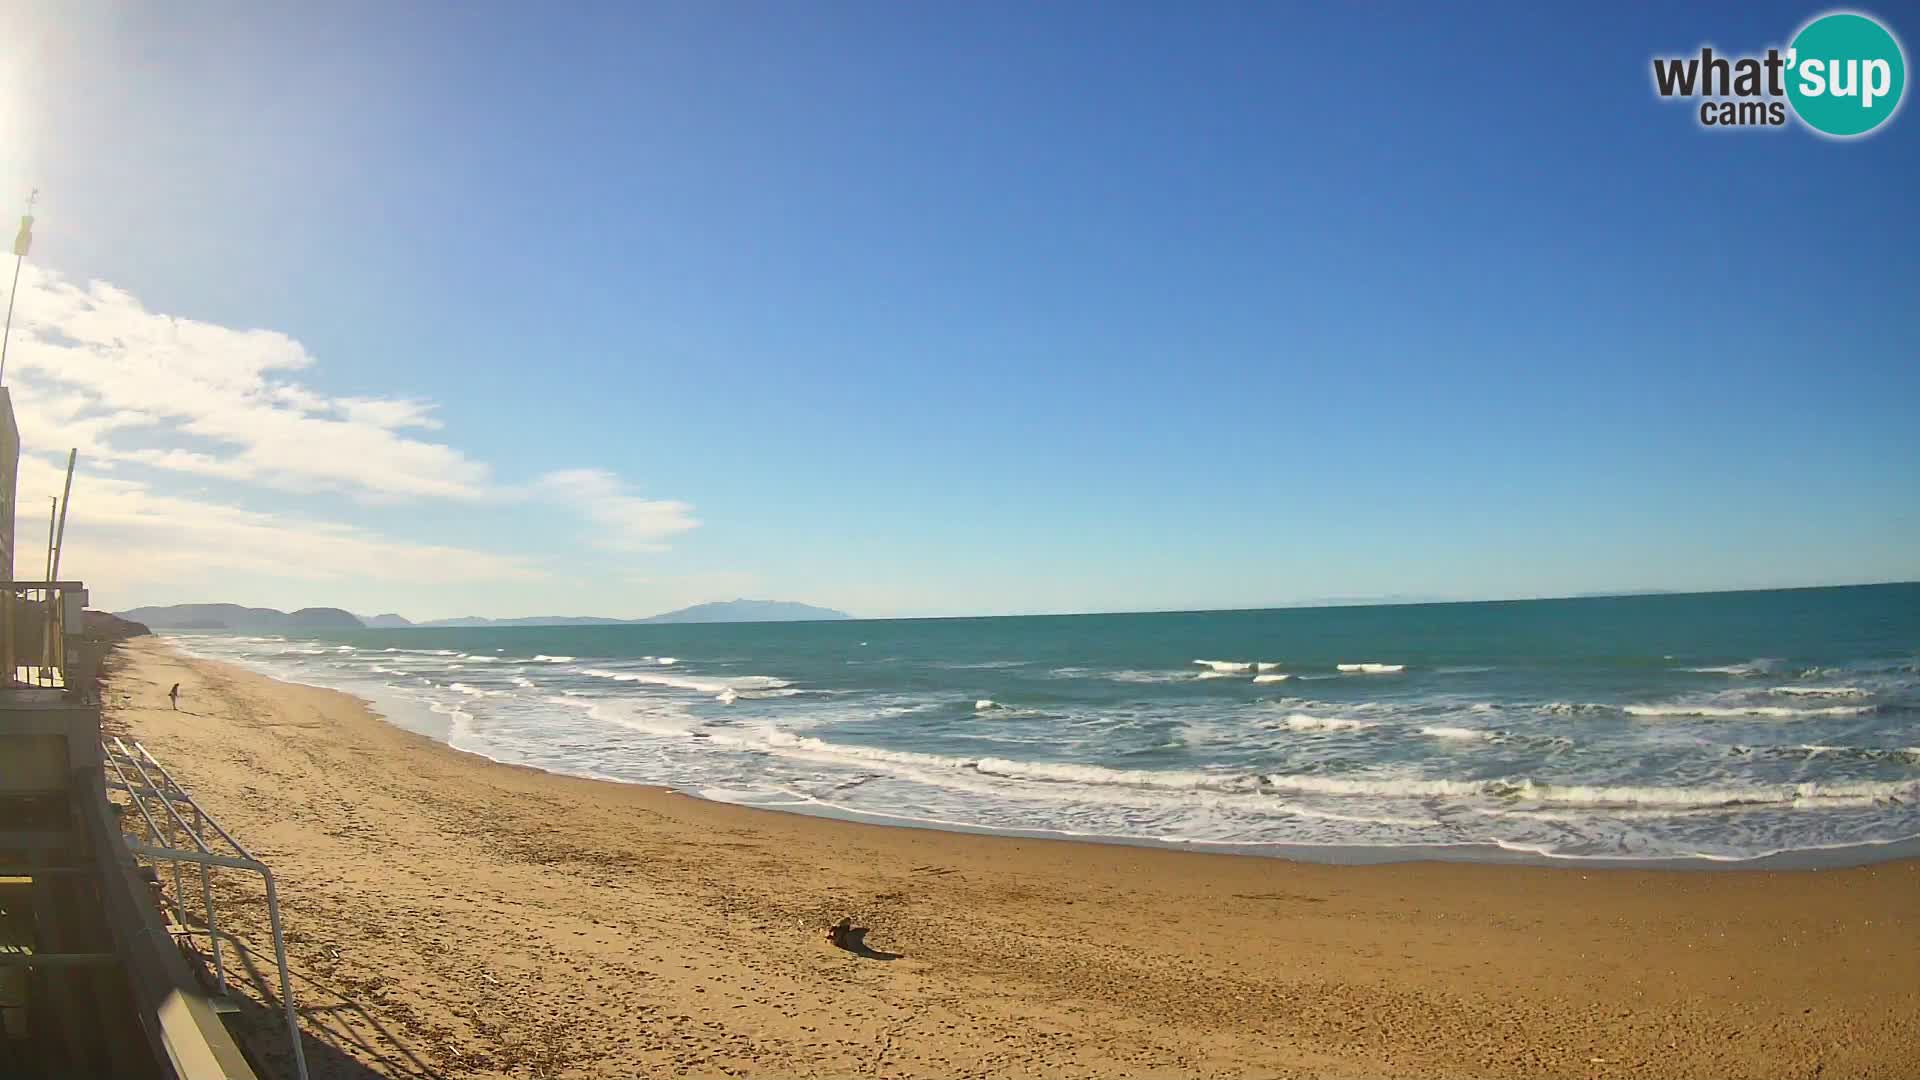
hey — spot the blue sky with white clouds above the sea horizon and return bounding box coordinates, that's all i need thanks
[0,0,1920,619]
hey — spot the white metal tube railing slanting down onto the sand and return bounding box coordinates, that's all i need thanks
[100,736,307,1080]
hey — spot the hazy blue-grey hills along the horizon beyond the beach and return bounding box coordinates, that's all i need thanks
[119,600,852,630]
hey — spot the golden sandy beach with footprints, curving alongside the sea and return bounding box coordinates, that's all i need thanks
[106,638,1920,1080]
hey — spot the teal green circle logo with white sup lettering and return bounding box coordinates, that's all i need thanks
[1788,12,1907,138]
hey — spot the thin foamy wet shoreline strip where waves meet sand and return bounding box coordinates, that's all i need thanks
[156,634,1920,872]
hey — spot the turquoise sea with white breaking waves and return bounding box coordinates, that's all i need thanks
[167,584,1920,867]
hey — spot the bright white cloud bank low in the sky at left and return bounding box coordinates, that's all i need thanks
[6,265,699,611]
